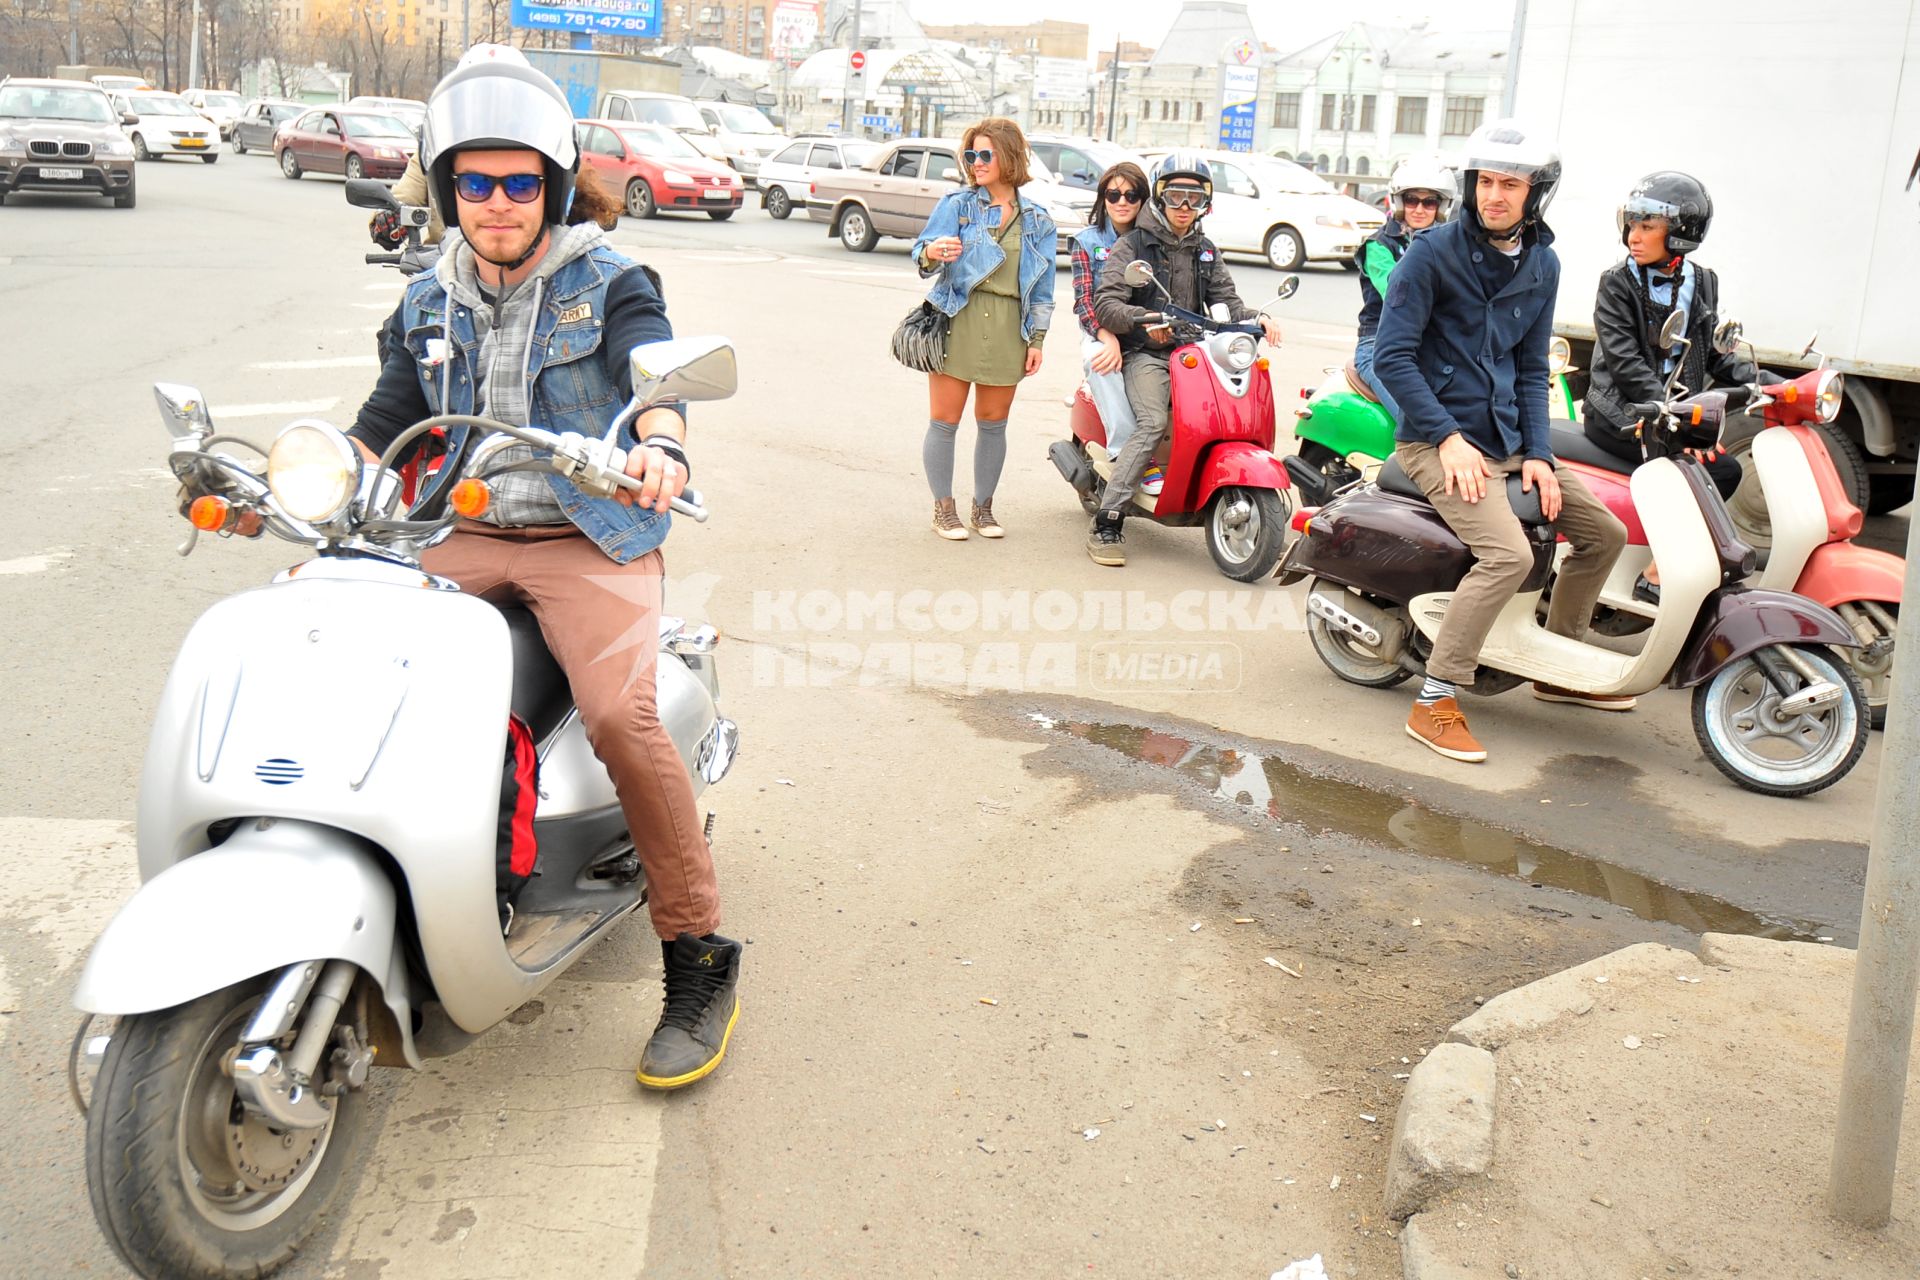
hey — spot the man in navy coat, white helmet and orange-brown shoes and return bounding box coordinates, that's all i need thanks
[1373,121,1634,764]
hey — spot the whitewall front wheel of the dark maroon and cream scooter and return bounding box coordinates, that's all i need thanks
[1693,645,1868,796]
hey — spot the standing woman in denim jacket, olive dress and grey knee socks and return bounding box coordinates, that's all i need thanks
[914,117,1058,541]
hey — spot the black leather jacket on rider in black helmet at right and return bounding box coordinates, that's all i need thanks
[1584,259,1755,438]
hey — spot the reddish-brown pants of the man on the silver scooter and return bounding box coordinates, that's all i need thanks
[420,522,720,938]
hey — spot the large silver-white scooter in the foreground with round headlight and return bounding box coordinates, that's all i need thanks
[69,338,739,1280]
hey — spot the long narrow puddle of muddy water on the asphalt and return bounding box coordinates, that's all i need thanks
[1059,716,1834,940]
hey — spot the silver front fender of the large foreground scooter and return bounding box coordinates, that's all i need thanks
[73,819,420,1067]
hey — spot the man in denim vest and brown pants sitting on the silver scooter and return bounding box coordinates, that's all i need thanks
[351,44,741,1088]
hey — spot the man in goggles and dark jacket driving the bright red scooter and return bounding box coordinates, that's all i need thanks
[1087,152,1281,566]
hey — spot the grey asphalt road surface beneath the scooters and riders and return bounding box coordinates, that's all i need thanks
[0,155,1903,1280]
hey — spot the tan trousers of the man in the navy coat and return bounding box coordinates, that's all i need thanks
[1394,443,1626,685]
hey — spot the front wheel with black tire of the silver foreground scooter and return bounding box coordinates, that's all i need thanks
[86,979,367,1280]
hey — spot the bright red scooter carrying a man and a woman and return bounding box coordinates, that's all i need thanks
[1046,261,1300,581]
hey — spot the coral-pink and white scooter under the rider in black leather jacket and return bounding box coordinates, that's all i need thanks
[1553,333,1907,729]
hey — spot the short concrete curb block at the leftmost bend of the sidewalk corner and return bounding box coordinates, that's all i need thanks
[1386,1044,1496,1219]
